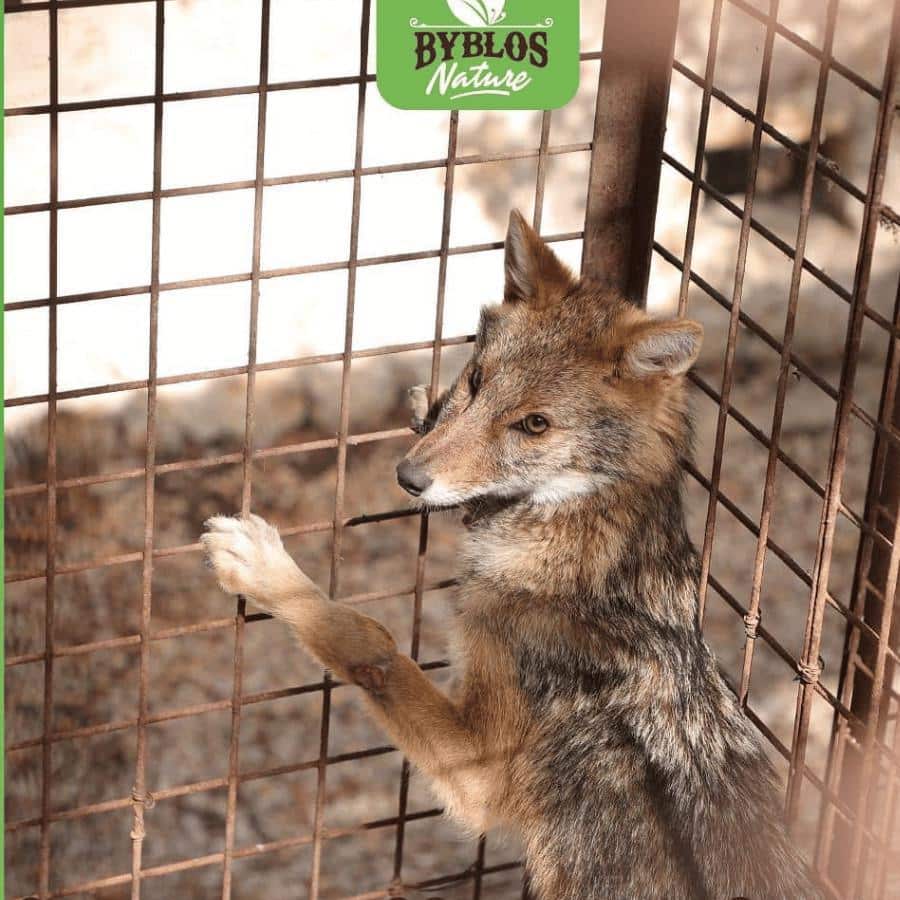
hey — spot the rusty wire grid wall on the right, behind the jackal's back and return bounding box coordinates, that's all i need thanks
[654,0,900,900]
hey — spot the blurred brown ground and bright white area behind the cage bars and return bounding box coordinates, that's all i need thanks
[4,0,900,900]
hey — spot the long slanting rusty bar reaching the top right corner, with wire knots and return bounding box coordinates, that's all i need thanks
[786,0,900,822]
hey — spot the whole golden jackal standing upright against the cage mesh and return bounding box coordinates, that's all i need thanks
[203,213,820,900]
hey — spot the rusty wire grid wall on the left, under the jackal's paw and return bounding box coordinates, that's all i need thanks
[5,0,600,900]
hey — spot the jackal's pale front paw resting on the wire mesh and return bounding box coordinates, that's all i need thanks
[200,515,311,612]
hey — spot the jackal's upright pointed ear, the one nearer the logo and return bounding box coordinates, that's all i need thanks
[504,209,578,308]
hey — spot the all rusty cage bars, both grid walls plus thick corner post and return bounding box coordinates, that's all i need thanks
[5,0,900,900]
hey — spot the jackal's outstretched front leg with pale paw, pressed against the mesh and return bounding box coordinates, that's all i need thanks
[201,516,491,828]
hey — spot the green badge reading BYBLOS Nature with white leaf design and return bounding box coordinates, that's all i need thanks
[378,0,580,109]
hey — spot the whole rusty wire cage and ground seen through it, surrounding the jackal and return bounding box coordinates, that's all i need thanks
[5,0,900,900]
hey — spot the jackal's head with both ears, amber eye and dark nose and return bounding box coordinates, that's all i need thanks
[397,212,703,507]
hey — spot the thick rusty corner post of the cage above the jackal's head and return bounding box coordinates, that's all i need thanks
[582,0,678,304]
